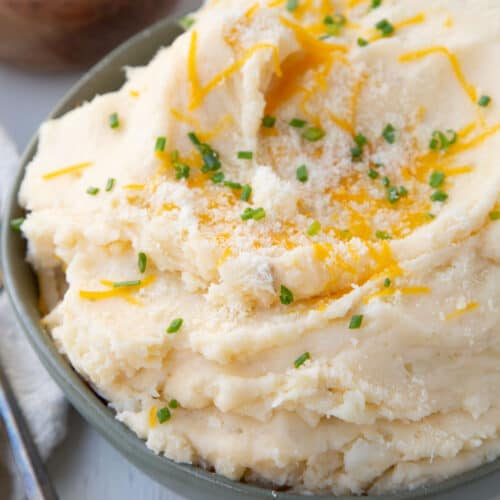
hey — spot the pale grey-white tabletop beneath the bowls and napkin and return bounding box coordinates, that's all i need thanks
[0,0,500,500]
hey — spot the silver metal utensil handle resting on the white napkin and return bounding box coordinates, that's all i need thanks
[0,360,57,500]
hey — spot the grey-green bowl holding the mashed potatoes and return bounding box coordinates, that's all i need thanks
[0,13,500,500]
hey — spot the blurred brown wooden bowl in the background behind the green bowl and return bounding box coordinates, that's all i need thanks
[0,0,177,70]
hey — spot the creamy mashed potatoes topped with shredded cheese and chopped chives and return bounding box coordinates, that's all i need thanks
[16,0,500,494]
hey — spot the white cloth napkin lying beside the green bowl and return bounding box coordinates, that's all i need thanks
[0,127,67,500]
